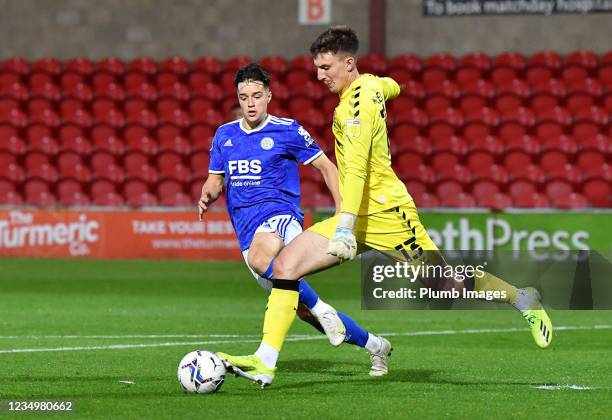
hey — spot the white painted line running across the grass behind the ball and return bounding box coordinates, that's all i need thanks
[0,325,612,354]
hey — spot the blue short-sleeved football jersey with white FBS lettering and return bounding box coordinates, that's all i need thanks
[208,115,323,250]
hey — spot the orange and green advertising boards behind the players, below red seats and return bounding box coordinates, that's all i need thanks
[0,209,612,260]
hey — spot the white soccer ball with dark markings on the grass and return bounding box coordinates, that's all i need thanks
[178,350,225,394]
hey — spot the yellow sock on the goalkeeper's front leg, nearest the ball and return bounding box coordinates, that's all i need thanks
[261,281,299,352]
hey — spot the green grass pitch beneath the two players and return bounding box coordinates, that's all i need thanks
[0,259,612,419]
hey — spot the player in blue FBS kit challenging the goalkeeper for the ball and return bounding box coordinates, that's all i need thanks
[198,63,391,376]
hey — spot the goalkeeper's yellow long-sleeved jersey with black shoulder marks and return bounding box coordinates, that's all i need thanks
[333,74,412,215]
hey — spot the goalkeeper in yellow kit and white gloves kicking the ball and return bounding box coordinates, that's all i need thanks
[219,26,552,386]
